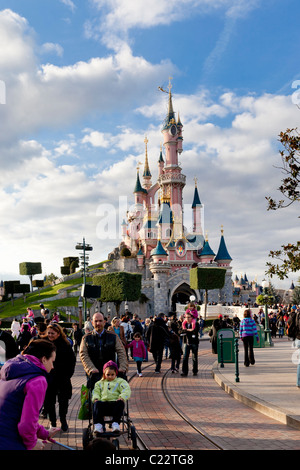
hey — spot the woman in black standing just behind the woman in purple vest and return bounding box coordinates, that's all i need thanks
[44,323,76,431]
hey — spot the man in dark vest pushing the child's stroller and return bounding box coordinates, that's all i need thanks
[79,312,128,388]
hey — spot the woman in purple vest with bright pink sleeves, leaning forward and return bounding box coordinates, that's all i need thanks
[0,339,60,450]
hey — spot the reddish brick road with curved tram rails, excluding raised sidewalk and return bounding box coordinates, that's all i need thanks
[41,342,300,451]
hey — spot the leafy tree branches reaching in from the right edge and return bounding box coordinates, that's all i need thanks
[266,128,300,279]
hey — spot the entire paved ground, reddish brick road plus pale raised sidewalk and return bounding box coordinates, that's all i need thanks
[39,337,300,451]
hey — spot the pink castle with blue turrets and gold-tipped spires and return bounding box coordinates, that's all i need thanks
[110,83,232,314]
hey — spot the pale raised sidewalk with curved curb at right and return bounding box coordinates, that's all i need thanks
[213,337,300,430]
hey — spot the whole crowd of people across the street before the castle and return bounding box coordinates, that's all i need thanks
[0,302,300,450]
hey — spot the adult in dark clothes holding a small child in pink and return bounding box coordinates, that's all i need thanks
[181,313,199,377]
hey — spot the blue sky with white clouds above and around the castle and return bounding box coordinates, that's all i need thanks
[0,0,300,287]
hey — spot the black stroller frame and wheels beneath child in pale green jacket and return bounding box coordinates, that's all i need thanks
[82,372,137,450]
